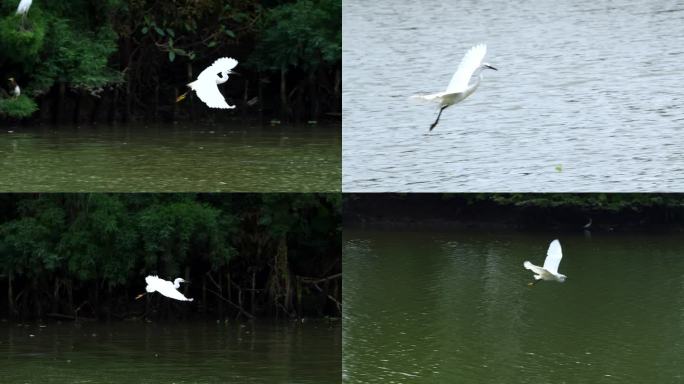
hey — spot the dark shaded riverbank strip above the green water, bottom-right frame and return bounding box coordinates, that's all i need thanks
[343,194,684,231]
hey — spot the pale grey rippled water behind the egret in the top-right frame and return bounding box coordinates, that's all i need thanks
[342,0,684,192]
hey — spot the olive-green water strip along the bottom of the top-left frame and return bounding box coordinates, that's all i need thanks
[0,125,341,192]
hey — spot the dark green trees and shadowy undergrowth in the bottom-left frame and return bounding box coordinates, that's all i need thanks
[0,194,341,320]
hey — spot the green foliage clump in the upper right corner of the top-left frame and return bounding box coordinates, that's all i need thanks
[252,0,342,71]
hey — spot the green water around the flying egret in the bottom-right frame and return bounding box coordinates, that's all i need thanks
[343,231,684,383]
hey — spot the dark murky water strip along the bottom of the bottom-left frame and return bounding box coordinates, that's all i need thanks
[0,322,341,384]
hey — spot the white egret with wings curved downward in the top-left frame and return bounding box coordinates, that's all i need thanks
[176,57,237,109]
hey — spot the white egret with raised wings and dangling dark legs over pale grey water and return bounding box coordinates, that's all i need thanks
[414,44,498,131]
